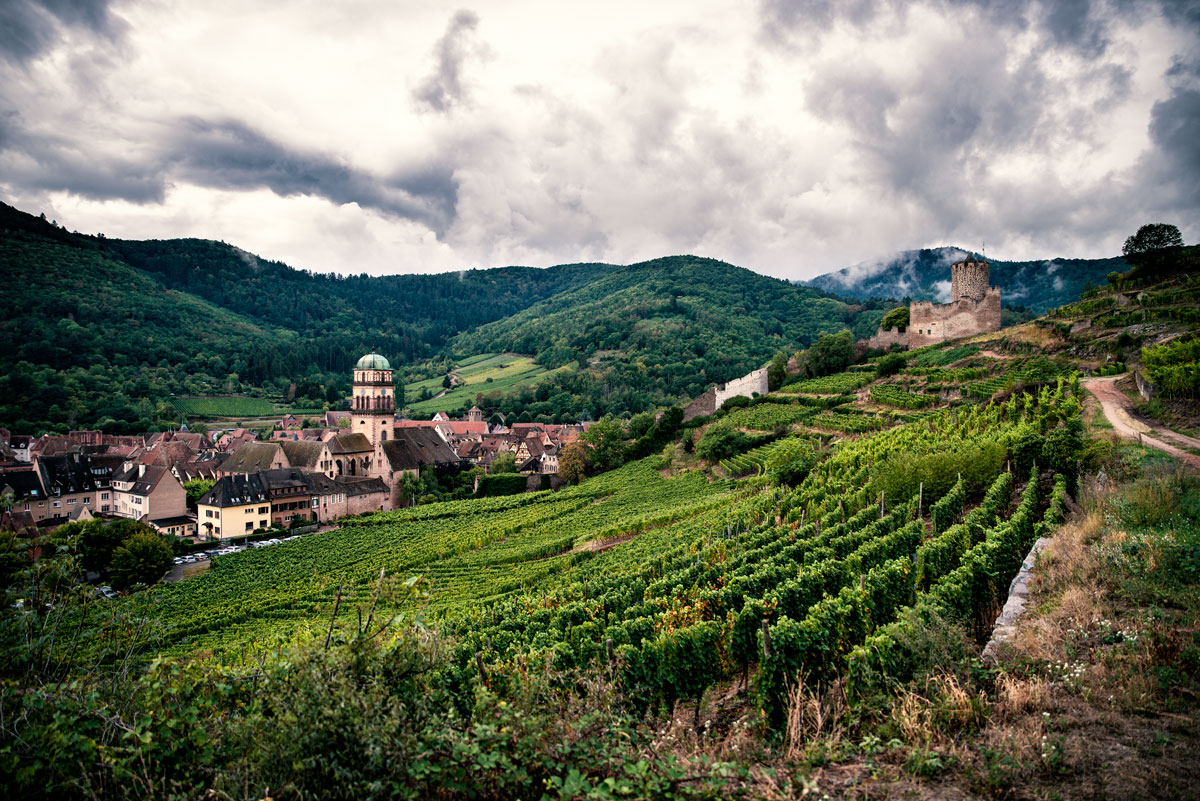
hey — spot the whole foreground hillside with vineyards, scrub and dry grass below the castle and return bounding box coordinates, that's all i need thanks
[0,264,1200,799]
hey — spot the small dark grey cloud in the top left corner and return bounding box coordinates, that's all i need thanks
[0,0,125,65]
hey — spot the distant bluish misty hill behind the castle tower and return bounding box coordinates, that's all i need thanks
[803,247,1129,314]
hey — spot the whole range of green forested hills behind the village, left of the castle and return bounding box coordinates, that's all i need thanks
[0,204,882,433]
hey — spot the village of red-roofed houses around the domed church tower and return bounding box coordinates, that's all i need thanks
[0,354,587,542]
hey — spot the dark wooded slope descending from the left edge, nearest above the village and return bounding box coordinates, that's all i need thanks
[0,226,300,433]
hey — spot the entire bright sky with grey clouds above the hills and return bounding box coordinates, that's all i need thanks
[0,0,1200,278]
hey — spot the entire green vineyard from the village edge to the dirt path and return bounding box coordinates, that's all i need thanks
[138,373,1079,723]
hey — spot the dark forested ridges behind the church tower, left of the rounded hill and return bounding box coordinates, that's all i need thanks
[0,204,614,433]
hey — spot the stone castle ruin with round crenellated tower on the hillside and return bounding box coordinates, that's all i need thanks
[868,255,1000,350]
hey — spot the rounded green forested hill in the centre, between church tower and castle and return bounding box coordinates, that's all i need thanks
[451,255,881,414]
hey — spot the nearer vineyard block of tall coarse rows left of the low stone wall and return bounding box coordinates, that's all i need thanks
[446,384,1079,722]
